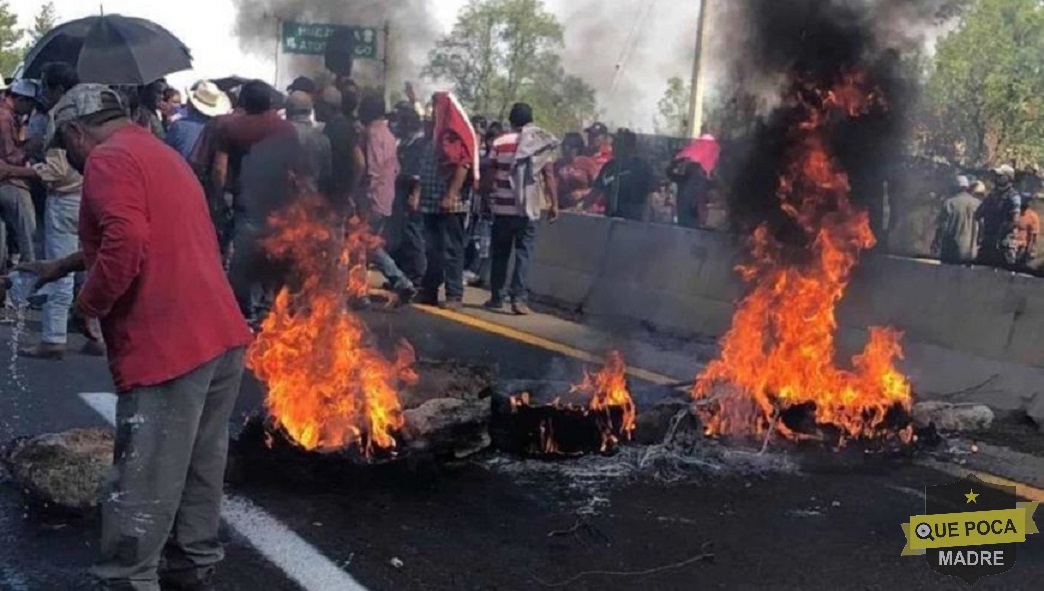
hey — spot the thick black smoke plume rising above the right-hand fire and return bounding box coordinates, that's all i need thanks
[711,0,960,237]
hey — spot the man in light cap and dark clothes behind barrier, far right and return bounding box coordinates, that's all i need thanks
[978,164,1022,266]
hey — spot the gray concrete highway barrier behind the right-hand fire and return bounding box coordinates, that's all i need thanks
[530,214,1044,423]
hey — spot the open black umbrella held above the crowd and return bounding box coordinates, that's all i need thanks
[22,15,192,85]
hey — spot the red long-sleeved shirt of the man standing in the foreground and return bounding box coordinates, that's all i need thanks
[79,125,251,393]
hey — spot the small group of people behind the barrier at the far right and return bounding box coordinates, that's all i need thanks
[931,165,1041,270]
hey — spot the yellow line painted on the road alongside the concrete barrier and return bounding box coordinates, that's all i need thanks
[413,305,1044,503]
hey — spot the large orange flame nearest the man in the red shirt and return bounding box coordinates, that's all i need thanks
[247,197,417,456]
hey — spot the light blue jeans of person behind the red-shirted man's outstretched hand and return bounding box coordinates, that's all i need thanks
[41,193,79,345]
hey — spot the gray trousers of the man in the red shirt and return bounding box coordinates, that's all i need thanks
[93,349,244,591]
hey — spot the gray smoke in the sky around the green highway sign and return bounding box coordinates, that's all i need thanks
[233,0,441,87]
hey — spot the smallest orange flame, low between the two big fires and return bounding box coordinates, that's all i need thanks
[511,351,638,455]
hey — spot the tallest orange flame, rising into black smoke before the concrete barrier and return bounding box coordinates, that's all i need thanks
[693,73,911,444]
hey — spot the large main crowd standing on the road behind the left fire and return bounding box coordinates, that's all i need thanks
[0,68,734,334]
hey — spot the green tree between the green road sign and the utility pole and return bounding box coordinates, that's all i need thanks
[425,0,597,134]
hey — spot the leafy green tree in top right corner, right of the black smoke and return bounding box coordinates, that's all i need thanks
[918,0,1044,165]
